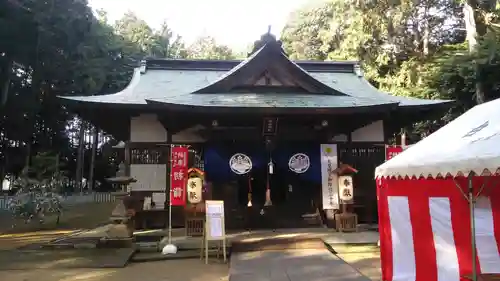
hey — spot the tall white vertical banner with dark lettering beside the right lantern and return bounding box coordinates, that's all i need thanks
[320,144,339,210]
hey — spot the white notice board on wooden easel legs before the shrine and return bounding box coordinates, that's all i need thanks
[200,200,227,264]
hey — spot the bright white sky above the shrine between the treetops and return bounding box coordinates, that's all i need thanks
[89,0,318,50]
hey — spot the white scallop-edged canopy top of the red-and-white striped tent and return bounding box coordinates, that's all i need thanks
[375,99,500,177]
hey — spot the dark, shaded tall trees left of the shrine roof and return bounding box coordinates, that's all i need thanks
[0,0,138,188]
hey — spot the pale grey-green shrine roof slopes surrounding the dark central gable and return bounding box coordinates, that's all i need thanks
[63,69,450,108]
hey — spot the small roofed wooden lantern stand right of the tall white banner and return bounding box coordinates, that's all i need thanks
[332,163,358,232]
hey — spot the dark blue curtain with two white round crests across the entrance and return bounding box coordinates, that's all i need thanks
[204,142,321,183]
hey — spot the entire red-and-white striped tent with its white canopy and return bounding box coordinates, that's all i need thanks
[375,100,500,281]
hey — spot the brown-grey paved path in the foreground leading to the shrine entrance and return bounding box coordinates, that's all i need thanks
[229,249,370,281]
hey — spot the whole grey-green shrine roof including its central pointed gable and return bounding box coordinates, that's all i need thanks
[57,31,449,108]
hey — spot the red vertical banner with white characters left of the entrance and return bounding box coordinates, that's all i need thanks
[170,146,188,206]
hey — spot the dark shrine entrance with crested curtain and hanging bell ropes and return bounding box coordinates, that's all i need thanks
[212,142,321,229]
